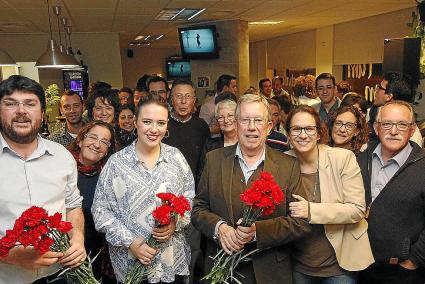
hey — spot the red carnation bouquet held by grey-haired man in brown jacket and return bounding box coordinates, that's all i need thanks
[202,171,284,284]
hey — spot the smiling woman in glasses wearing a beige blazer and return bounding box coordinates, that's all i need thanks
[286,105,373,284]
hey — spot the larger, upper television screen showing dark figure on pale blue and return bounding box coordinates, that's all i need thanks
[178,26,219,59]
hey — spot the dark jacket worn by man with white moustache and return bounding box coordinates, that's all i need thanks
[357,142,425,267]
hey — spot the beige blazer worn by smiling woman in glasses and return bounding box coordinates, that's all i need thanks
[288,145,374,271]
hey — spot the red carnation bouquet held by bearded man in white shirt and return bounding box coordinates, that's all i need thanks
[0,206,100,284]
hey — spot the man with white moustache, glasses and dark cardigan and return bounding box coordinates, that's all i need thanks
[358,100,425,284]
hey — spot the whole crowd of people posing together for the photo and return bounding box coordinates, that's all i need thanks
[0,70,425,284]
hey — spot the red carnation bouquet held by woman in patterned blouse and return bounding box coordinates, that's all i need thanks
[124,192,190,284]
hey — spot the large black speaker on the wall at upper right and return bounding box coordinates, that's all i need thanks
[382,38,421,87]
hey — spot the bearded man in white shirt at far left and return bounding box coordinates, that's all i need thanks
[0,75,86,283]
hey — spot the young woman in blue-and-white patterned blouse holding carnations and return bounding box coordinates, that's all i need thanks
[92,94,195,283]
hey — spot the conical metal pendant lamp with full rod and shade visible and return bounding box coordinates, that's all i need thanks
[35,0,79,69]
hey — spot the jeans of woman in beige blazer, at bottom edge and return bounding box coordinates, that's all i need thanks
[292,271,358,284]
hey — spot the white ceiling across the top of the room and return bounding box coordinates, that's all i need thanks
[0,0,416,47]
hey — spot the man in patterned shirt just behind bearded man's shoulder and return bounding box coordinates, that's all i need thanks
[48,90,83,147]
